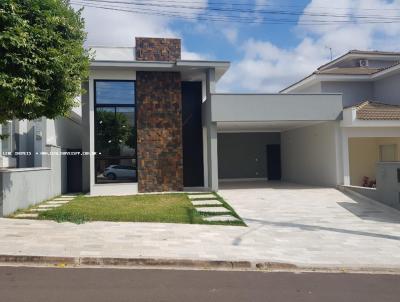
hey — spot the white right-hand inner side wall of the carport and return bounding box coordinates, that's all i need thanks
[281,122,341,186]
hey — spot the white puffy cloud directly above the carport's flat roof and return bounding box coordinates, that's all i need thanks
[218,38,328,92]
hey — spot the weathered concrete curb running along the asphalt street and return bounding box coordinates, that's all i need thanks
[0,255,400,274]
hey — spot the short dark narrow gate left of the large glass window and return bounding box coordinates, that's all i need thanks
[67,149,82,193]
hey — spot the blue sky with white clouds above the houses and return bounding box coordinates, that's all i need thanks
[71,0,400,92]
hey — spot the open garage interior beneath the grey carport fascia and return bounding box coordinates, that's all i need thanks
[218,121,340,187]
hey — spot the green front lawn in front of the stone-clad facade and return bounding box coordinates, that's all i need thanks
[38,193,244,225]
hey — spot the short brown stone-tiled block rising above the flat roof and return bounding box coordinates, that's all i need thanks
[135,38,181,61]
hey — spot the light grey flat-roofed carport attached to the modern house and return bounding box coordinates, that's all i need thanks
[203,94,342,190]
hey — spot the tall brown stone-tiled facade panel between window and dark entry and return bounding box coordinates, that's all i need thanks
[136,71,183,192]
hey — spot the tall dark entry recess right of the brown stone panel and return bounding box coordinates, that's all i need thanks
[182,82,204,187]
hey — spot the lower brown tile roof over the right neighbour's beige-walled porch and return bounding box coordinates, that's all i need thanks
[352,101,400,120]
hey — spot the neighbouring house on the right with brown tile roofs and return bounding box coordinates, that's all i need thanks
[282,50,400,208]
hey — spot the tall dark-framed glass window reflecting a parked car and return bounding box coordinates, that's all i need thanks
[95,80,137,183]
